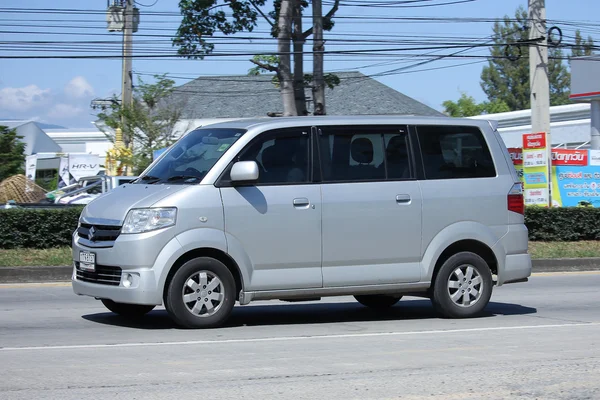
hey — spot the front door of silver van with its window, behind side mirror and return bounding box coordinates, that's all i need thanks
[221,128,323,291]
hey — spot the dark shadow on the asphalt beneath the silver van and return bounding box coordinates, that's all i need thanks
[82,299,537,330]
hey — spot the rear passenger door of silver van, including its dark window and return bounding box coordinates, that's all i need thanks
[319,126,421,287]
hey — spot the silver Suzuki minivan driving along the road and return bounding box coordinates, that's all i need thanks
[72,116,531,328]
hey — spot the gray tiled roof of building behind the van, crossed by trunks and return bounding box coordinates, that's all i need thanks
[169,71,443,119]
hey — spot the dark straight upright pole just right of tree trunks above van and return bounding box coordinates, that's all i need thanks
[312,0,326,115]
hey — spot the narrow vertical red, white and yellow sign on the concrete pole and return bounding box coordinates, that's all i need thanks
[522,132,549,207]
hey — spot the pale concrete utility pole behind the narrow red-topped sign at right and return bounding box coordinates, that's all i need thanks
[528,0,552,207]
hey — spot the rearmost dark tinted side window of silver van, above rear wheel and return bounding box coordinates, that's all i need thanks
[417,125,496,179]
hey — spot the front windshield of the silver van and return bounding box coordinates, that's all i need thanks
[132,128,246,185]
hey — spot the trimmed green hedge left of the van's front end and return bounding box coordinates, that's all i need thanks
[0,206,83,249]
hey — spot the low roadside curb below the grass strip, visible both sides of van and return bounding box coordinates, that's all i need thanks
[0,257,600,283]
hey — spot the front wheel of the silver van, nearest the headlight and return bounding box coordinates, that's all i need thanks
[165,257,236,328]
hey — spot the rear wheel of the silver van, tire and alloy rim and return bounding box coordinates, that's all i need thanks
[431,252,493,318]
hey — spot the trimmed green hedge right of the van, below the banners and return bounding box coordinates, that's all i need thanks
[525,207,600,242]
